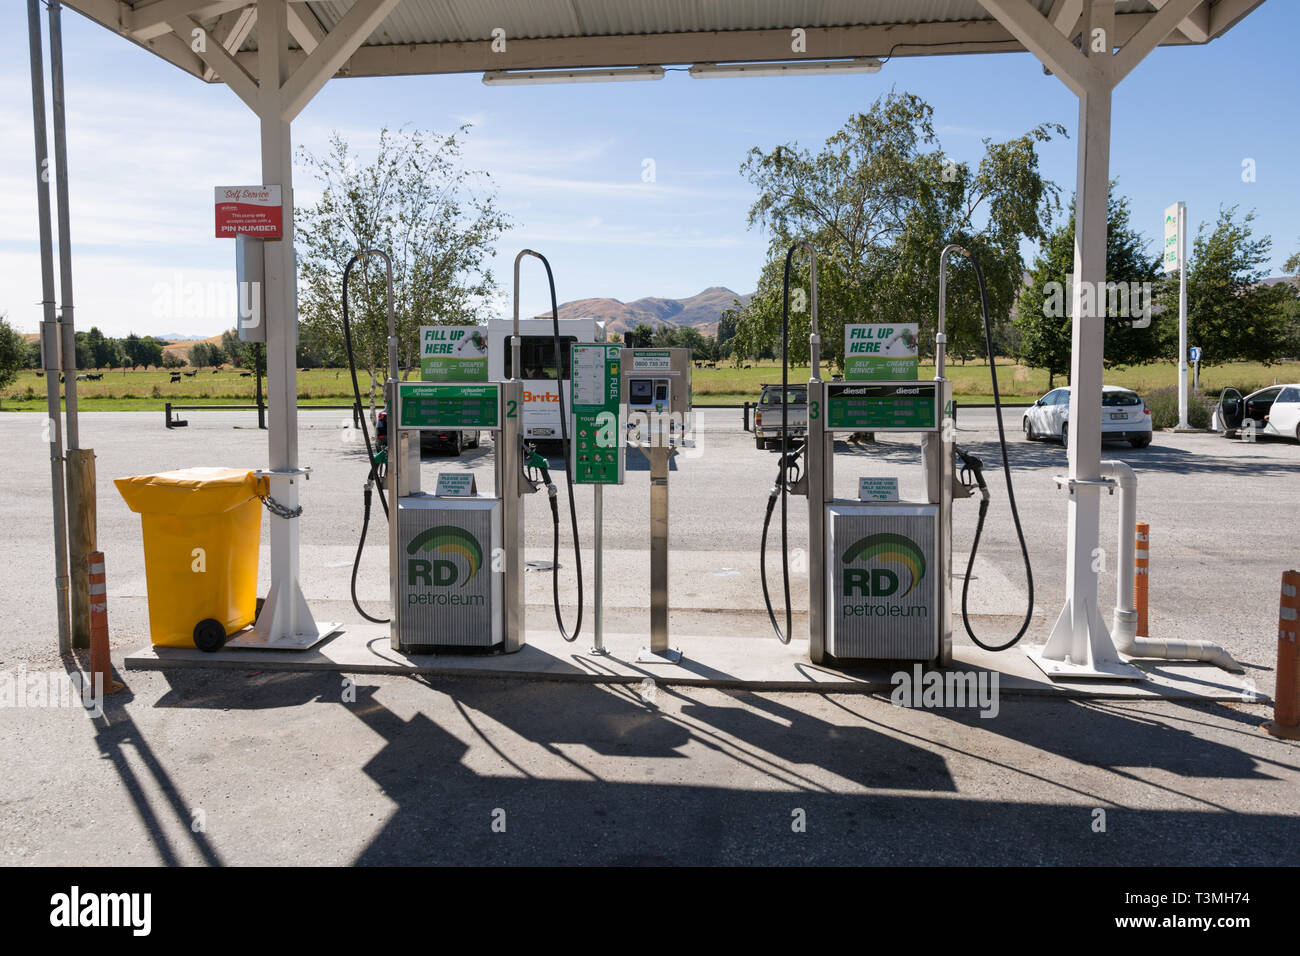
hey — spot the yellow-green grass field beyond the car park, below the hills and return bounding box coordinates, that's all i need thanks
[0,362,1300,411]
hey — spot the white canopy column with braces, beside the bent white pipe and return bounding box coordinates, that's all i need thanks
[980,0,1201,680]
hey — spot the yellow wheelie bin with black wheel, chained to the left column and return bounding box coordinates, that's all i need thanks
[114,468,268,652]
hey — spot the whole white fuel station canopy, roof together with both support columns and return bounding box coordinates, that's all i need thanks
[48,0,1264,679]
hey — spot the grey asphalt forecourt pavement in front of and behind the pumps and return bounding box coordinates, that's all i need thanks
[0,408,1300,865]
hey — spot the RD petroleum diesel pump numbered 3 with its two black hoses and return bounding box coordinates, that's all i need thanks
[759,243,1034,666]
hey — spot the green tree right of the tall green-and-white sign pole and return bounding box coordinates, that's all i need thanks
[1158,206,1295,365]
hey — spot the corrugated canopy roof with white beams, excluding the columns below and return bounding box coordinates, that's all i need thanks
[58,0,1262,82]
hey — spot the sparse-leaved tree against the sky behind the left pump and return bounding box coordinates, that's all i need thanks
[296,126,510,403]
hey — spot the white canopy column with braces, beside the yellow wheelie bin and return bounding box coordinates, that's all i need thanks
[169,0,399,649]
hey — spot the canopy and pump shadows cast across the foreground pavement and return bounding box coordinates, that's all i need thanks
[134,671,1300,865]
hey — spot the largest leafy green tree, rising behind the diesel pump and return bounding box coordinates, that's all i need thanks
[735,92,1065,367]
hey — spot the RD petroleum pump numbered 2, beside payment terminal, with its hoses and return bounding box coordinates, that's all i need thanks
[343,250,582,653]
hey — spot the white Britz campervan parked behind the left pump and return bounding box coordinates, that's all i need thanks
[488,319,605,441]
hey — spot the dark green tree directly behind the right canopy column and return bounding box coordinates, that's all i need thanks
[1014,181,1165,389]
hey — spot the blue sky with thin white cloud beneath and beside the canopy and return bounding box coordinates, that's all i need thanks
[0,0,1300,336]
